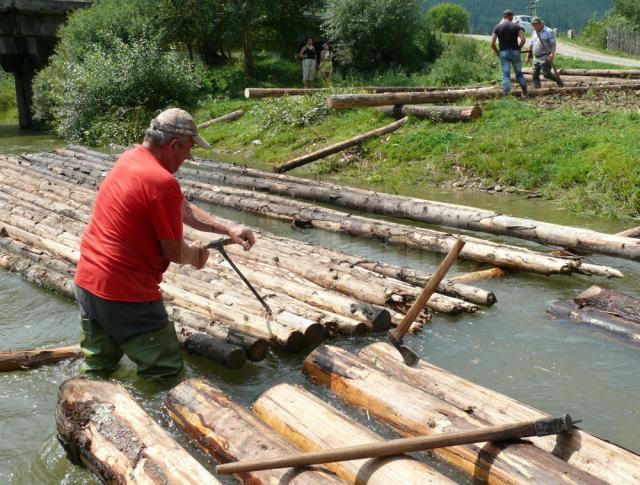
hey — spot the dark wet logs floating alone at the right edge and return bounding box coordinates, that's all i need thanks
[547,286,640,344]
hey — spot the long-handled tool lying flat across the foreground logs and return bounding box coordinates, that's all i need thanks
[216,415,573,474]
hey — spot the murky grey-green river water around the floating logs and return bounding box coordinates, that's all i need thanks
[0,127,640,485]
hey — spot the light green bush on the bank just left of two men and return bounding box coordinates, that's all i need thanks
[428,37,498,86]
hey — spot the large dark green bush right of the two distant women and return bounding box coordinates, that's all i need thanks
[323,0,438,72]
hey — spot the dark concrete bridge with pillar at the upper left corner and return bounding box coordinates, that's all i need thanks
[0,0,91,128]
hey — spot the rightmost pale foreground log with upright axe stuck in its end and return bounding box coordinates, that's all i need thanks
[358,343,640,483]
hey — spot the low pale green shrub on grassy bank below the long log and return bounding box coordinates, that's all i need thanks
[251,95,331,133]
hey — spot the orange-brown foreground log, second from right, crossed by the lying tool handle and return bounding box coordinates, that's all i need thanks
[304,346,602,484]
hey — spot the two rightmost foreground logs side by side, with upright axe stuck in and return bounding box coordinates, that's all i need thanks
[304,343,640,484]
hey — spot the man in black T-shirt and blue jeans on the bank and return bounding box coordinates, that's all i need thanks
[491,10,527,97]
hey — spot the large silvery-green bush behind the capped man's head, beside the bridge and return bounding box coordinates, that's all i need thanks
[34,34,202,145]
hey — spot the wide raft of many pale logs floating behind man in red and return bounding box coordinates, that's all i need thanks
[0,149,496,368]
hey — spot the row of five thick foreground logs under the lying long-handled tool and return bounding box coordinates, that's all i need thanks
[57,343,640,485]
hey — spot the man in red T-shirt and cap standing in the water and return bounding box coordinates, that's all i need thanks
[75,108,255,381]
